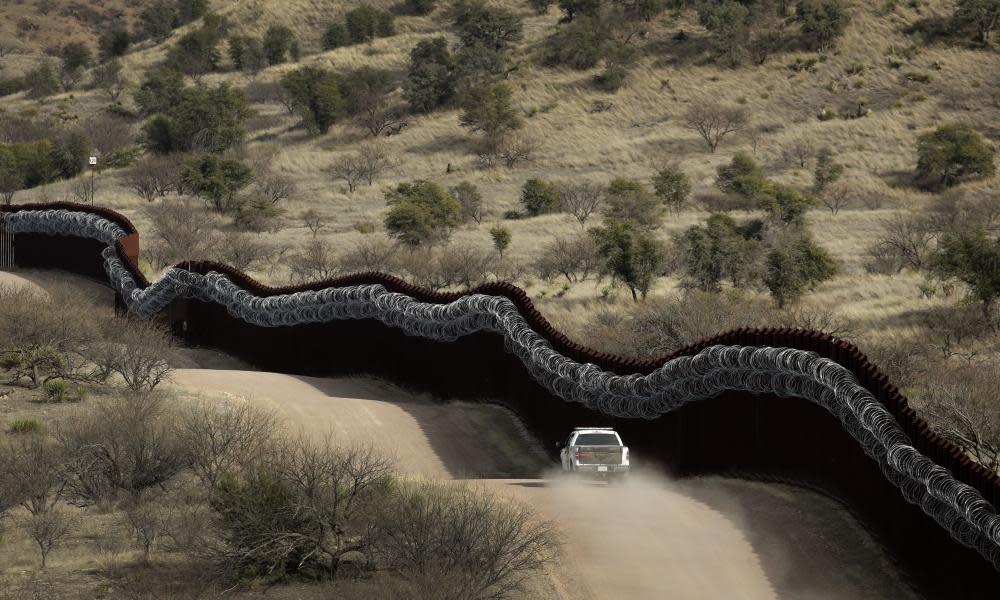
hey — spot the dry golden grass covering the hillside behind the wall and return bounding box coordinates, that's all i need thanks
[3,0,1000,398]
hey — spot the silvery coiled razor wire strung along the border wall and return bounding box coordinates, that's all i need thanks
[4,209,1000,569]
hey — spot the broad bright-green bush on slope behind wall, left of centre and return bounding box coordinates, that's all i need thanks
[385,180,462,246]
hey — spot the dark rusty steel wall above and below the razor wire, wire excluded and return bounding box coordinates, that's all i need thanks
[0,203,1000,599]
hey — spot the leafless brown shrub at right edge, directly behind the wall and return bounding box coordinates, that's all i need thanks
[926,365,1000,472]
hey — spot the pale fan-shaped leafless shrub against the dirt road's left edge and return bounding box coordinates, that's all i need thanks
[174,400,278,490]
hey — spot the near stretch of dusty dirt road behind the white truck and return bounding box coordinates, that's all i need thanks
[496,471,916,600]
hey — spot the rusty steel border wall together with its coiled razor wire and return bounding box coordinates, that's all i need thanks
[6,204,1000,598]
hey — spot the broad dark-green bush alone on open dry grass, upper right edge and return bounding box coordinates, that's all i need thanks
[916,123,996,190]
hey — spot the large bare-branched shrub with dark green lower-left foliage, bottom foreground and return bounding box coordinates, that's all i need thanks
[212,437,392,576]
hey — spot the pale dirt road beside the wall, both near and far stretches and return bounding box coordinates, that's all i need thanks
[168,369,914,600]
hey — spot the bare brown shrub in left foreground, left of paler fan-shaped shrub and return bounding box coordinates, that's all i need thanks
[56,395,188,505]
